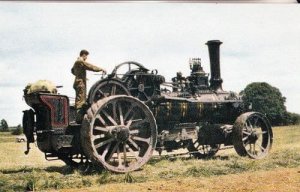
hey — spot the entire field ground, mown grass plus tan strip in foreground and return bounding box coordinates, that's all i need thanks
[0,126,300,192]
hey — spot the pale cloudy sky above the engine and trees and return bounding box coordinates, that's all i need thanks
[0,2,300,125]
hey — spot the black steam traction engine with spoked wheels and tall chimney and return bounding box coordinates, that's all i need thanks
[23,40,273,172]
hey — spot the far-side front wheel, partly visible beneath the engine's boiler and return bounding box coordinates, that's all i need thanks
[187,140,220,159]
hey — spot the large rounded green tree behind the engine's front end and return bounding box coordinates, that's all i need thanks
[241,82,287,125]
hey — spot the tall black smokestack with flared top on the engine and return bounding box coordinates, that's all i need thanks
[206,40,223,91]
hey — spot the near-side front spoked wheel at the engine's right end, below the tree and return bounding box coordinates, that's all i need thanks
[233,112,273,159]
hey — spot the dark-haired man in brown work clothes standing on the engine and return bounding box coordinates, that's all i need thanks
[71,50,106,122]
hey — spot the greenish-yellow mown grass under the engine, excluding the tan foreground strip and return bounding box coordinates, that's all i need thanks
[0,126,300,191]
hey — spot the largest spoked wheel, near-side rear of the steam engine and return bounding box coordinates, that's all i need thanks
[81,95,157,173]
